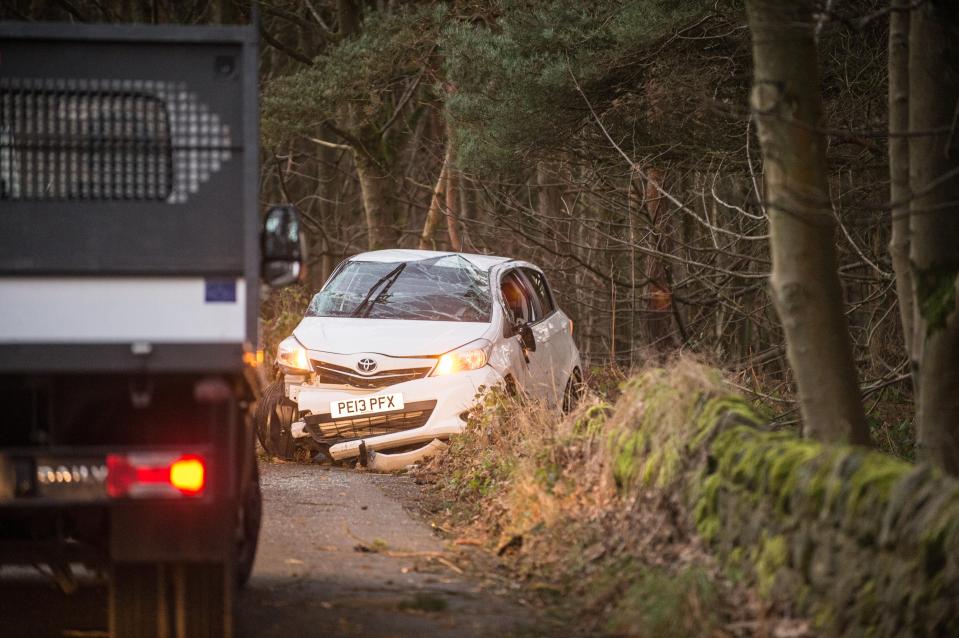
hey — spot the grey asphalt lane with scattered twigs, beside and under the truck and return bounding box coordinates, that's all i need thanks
[0,463,530,638]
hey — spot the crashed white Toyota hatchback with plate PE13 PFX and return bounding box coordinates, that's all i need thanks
[269,250,582,469]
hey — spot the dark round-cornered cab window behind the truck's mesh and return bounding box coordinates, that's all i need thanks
[0,86,173,200]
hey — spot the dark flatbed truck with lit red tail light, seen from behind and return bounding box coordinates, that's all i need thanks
[0,17,302,638]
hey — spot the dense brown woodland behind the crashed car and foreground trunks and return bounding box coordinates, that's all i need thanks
[0,0,913,458]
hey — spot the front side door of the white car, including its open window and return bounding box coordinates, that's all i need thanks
[500,268,553,401]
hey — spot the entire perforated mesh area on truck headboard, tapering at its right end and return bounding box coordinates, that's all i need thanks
[0,77,238,204]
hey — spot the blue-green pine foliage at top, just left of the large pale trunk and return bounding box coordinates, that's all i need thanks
[442,0,712,172]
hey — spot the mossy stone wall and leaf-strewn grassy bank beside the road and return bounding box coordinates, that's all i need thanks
[416,361,959,637]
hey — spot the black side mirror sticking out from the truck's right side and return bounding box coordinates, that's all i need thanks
[260,205,306,288]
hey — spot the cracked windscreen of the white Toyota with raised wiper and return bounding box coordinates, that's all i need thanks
[306,255,492,323]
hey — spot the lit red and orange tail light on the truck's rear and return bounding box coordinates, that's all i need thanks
[107,452,207,498]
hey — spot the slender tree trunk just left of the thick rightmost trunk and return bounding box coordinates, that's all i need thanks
[889,0,913,359]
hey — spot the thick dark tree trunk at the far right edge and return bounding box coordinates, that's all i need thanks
[909,0,959,475]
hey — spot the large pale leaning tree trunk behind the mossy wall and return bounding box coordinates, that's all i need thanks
[746,0,869,444]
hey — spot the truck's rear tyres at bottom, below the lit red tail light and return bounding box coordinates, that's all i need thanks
[109,563,233,638]
